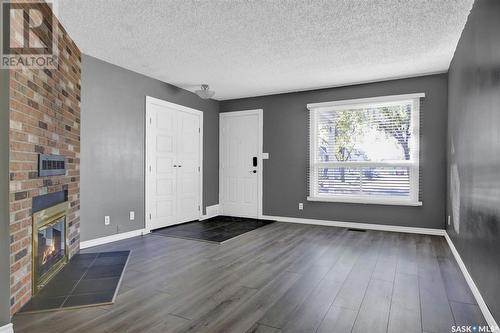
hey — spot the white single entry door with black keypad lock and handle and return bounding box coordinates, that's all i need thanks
[219,110,262,218]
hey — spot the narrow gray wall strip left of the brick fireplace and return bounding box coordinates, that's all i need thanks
[0,69,10,327]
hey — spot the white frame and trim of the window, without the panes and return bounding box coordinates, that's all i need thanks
[307,93,425,206]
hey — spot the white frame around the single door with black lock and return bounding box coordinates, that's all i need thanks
[219,109,264,219]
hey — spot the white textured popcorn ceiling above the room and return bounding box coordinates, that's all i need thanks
[54,0,473,100]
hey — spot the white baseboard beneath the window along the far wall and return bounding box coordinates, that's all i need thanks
[262,215,446,236]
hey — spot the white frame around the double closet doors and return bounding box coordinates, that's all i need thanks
[144,96,203,232]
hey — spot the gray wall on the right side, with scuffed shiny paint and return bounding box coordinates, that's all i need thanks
[448,0,500,321]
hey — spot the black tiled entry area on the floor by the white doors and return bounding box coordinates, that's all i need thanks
[153,216,274,244]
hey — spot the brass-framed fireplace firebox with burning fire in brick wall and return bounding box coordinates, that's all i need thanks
[33,202,68,294]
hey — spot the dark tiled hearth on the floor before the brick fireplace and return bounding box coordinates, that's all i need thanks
[19,251,130,313]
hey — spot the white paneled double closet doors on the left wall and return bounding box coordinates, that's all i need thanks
[146,97,202,229]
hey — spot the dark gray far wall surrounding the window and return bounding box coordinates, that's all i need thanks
[221,74,447,229]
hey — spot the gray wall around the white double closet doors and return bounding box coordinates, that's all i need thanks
[81,55,219,241]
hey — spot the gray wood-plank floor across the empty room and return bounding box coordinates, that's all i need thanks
[13,223,485,333]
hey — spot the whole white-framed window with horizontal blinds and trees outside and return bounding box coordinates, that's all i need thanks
[307,94,425,206]
